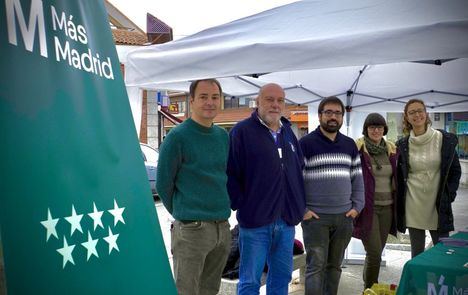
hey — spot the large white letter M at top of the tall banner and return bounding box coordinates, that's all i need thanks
[5,0,47,57]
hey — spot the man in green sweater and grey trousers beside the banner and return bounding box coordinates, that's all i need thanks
[156,79,231,295]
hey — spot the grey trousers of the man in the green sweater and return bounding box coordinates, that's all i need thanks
[171,220,231,295]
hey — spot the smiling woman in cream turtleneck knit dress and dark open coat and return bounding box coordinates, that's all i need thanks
[397,99,461,257]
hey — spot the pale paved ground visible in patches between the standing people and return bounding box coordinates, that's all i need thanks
[155,188,468,295]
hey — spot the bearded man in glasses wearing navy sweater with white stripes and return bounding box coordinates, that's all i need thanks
[300,96,364,295]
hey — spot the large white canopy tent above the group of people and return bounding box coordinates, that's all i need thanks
[126,0,468,132]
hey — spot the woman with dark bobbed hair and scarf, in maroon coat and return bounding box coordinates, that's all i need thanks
[353,113,397,289]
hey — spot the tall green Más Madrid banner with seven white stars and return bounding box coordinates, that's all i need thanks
[0,0,176,295]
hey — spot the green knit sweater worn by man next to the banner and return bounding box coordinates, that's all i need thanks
[156,119,231,220]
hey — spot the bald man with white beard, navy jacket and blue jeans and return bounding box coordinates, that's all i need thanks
[227,84,305,295]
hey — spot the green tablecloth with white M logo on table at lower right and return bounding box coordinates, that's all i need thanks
[397,233,468,295]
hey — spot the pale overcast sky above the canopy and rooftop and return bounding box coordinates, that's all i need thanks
[109,0,297,39]
